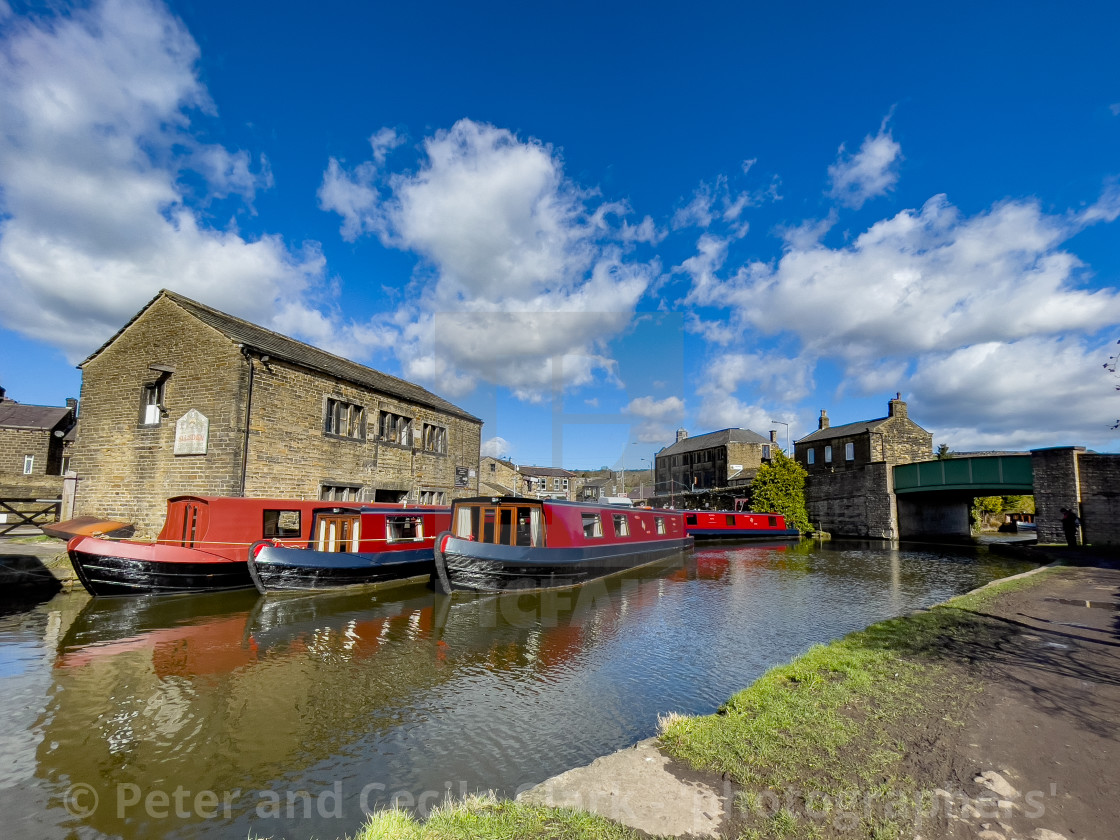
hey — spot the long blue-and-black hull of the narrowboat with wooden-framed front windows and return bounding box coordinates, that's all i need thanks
[432,533,693,595]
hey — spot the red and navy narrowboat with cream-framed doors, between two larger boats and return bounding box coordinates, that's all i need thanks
[249,505,451,594]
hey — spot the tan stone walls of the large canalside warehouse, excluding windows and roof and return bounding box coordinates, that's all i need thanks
[71,298,482,536]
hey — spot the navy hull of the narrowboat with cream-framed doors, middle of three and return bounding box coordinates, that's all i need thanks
[249,544,435,594]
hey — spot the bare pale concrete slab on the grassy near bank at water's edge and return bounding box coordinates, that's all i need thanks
[517,738,726,837]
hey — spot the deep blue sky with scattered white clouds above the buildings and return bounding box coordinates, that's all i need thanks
[0,0,1120,468]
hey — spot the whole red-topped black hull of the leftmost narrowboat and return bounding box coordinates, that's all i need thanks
[67,538,253,597]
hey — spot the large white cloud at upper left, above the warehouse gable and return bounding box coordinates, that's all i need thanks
[0,0,323,360]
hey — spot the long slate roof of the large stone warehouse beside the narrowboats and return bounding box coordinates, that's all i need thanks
[78,289,482,423]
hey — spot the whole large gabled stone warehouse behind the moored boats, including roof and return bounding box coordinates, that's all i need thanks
[72,290,482,535]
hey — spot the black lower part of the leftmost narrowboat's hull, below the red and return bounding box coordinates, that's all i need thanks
[69,550,253,597]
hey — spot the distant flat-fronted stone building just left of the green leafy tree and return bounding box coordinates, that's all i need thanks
[654,429,778,500]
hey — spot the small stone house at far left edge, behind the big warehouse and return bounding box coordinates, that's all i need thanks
[0,388,77,484]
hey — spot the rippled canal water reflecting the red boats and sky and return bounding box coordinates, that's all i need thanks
[0,542,1029,840]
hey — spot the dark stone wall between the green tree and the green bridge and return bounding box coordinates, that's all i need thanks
[805,463,898,540]
